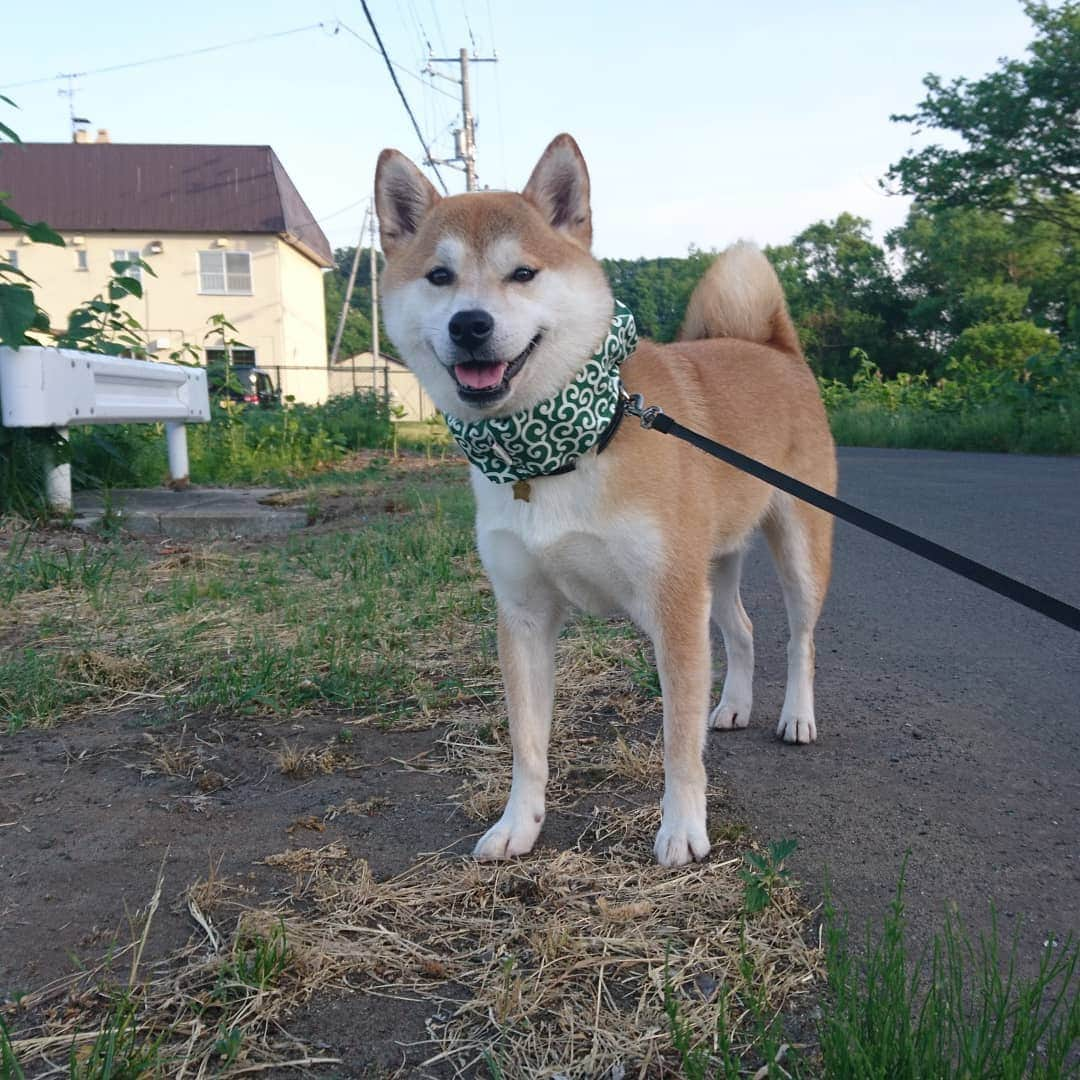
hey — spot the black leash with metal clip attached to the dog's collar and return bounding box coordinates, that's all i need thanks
[624,394,1080,630]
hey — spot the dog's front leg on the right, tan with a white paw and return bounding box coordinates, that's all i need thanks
[651,582,712,866]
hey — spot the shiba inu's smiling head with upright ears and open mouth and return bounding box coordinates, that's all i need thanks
[375,135,611,420]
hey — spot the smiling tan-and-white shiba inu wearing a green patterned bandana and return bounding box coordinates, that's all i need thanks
[375,135,836,866]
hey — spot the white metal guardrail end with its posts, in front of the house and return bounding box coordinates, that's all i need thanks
[0,346,210,509]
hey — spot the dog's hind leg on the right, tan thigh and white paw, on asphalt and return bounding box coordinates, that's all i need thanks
[762,492,833,743]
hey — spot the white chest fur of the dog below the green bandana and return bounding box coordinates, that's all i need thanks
[473,460,660,617]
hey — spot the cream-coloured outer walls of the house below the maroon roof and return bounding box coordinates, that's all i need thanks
[10,232,327,403]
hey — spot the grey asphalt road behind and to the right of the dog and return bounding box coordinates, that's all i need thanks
[708,449,1080,966]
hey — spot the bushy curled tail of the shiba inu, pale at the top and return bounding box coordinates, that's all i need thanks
[676,241,802,356]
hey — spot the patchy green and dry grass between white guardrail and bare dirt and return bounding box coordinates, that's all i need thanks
[0,463,496,731]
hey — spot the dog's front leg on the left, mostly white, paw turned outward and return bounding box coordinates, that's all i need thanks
[474,596,565,859]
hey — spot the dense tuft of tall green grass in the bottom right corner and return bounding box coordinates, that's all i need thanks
[819,870,1080,1080]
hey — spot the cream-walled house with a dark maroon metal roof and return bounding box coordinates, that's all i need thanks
[0,132,334,403]
